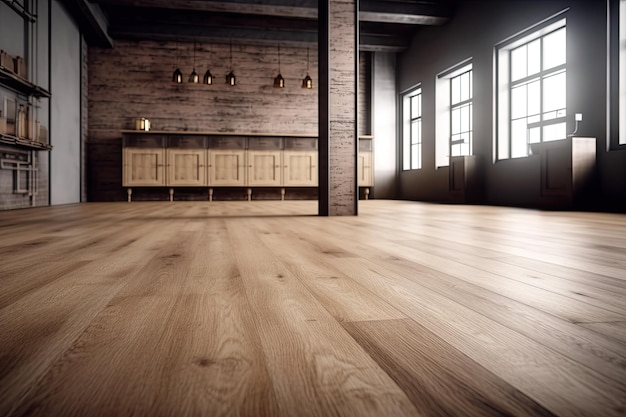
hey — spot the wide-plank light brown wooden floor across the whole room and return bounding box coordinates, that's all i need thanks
[0,200,626,417]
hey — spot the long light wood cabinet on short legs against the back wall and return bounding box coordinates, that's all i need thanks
[122,130,374,201]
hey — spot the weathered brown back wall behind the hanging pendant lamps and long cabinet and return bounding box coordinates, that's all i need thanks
[88,41,320,201]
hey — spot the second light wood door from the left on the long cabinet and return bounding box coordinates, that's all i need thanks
[167,149,207,187]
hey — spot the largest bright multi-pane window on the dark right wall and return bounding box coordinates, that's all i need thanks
[496,15,567,159]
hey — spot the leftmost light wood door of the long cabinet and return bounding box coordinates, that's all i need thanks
[122,148,165,187]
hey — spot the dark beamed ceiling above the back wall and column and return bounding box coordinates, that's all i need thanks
[65,0,455,52]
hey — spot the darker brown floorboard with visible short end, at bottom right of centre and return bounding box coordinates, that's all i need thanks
[343,319,553,416]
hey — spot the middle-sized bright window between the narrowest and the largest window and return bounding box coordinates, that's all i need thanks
[435,60,473,167]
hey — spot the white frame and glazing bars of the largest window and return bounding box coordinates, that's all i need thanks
[493,12,569,162]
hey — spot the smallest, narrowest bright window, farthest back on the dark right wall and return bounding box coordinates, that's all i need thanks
[402,88,422,170]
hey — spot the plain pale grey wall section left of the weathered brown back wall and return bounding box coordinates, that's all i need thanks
[50,0,81,205]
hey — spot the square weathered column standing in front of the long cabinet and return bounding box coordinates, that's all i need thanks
[318,0,358,216]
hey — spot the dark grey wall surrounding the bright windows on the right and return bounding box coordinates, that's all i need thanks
[398,0,626,206]
